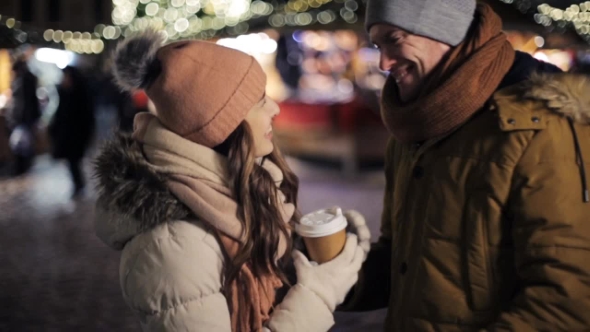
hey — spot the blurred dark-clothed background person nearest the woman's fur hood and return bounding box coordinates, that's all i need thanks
[48,66,95,197]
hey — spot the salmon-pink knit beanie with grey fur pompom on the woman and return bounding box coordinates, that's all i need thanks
[114,31,266,147]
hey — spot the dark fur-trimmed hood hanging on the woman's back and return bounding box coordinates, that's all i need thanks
[95,134,192,250]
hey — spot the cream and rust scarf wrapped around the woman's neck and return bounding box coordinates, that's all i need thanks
[133,113,295,332]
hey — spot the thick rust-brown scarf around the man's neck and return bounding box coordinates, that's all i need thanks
[381,4,515,143]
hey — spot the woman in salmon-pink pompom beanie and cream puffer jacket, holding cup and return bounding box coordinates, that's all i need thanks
[96,32,368,332]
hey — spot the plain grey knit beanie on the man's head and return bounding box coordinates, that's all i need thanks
[365,0,476,46]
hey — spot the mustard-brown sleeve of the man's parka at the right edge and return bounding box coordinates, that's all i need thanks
[488,128,590,331]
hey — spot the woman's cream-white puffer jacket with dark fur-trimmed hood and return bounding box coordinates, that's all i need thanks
[95,137,334,332]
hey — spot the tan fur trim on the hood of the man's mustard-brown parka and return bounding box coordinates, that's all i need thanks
[524,73,590,125]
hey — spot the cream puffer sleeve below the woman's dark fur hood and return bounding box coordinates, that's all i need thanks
[121,228,231,332]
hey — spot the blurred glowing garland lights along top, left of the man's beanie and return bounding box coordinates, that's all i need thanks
[0,0,365,54]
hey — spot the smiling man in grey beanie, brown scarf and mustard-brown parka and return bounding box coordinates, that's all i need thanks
[343,0,590,331]
